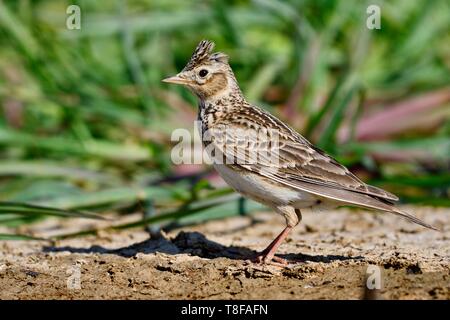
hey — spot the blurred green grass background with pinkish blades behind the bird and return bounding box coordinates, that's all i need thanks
[0,0,450,239]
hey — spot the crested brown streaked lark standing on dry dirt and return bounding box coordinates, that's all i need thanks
[162,40,437,265]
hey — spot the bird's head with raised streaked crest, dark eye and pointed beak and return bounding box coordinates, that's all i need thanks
[163,40,240,99]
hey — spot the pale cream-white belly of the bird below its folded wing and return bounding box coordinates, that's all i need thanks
[214,164,317,209]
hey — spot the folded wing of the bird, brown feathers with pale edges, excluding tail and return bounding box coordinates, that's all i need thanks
[211,109,398,202]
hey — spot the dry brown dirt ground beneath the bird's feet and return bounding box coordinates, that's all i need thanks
[0,207,450,299]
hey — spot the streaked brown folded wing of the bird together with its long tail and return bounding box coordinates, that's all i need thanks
[209,110,436,229]
